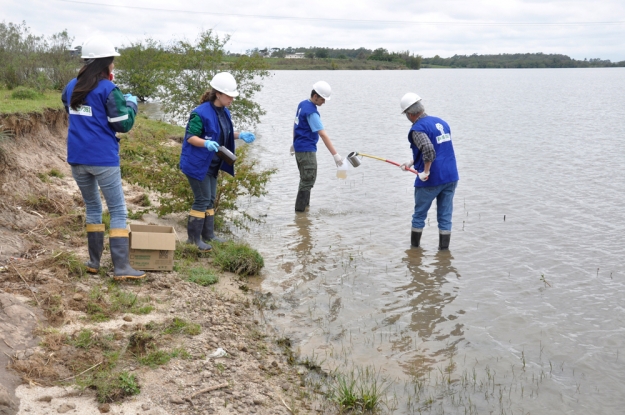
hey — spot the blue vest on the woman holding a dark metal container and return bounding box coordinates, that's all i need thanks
[180,102,234,180]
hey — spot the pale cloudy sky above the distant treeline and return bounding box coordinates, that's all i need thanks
[0,0,625,61]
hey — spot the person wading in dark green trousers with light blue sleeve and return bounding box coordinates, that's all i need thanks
[291,81,343,212]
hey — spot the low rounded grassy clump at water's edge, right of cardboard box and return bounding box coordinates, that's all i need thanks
[213,242,265,276]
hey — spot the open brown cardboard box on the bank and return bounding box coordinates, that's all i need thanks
[128,224,176,271]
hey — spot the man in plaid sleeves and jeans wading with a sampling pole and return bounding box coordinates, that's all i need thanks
[400,92,459,249]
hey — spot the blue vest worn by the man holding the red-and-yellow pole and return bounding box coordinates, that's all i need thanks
[408,115,458,187]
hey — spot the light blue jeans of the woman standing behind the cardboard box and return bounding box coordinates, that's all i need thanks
[72,164,128,229]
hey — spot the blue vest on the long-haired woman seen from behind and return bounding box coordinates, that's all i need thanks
[66,78,119,166]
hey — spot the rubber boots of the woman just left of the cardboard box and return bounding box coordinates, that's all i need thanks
[85,223,145,281]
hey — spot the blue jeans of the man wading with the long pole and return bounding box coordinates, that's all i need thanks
[412,181,458,233]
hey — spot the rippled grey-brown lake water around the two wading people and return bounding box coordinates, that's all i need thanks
[157,68,625,414]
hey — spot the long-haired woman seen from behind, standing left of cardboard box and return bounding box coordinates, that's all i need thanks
[61,36,145,280]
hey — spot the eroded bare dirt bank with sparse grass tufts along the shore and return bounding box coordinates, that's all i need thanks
[0,111,334,415]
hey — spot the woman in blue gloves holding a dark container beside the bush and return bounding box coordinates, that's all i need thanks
[180,72,256,251]
